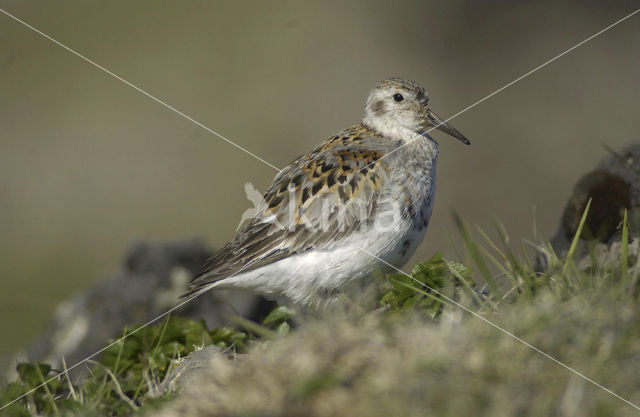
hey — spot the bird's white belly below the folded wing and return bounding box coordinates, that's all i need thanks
[216,190,431,304]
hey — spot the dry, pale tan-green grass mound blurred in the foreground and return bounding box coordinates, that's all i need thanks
[157,293,640,417]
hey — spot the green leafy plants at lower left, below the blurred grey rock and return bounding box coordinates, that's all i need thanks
[0,317,248,416]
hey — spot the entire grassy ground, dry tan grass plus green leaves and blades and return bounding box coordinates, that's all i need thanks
[0,210,640,416]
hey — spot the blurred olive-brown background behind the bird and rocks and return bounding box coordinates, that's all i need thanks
[0,0,640,365]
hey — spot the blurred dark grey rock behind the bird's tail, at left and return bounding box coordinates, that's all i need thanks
[7,239,273,380]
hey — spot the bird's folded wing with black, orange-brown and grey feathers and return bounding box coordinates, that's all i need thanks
[183,130,389,297]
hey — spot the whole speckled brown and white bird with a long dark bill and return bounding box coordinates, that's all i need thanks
[181,77,470,307]
